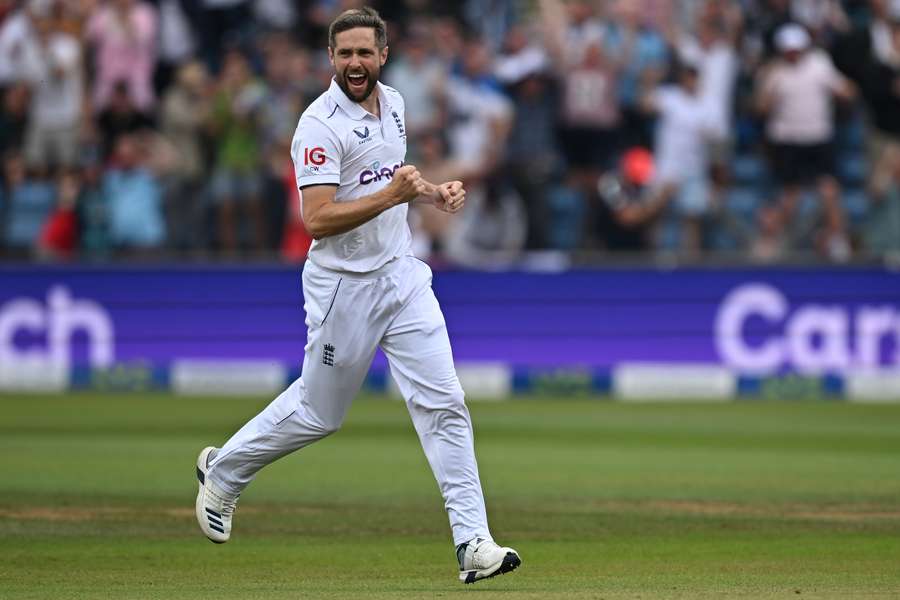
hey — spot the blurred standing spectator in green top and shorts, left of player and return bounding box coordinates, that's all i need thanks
[210,49,265,252]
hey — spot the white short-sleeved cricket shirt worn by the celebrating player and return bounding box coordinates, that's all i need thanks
[291,80,412,273]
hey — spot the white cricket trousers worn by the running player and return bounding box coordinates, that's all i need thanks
[207,256,491,545]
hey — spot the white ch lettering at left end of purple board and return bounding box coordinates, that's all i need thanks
[0,286,115,371]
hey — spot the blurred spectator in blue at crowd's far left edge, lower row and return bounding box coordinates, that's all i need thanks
[3,152,56,257]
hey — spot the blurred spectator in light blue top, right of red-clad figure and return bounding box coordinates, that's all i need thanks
[103,133,166,254]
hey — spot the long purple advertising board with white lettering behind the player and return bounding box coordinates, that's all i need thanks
[0,265,900,375]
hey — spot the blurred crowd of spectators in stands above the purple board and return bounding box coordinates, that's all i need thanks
[0,0,900,267]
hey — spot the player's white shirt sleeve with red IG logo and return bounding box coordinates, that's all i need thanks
[291,116,343,188]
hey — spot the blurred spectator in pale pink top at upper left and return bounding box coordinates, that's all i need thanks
[85,0,158,112]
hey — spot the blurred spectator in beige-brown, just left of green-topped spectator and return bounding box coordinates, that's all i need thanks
[161,62,210,250]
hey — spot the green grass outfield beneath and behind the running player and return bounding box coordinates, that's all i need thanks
[0,395,900,600]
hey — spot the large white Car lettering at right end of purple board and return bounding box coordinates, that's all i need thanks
[715,283,900,375]
